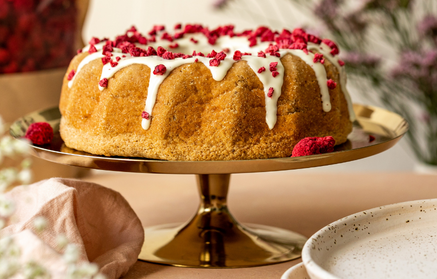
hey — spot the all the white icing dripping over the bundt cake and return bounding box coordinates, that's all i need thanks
[68,34,355,130]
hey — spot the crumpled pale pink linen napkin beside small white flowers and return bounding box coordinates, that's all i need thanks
[0,178,144,279]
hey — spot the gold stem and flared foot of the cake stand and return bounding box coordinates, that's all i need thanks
[139,174,306,268]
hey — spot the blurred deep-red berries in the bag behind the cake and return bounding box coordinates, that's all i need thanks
[0,0,77,74]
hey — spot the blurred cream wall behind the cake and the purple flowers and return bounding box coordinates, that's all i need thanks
[83,0,415,171]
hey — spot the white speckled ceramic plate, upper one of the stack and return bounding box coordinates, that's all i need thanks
[302,200,437,279]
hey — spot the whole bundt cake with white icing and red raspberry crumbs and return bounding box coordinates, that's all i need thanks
[59,25,354,161]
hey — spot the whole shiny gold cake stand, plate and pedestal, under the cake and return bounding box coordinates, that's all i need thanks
[10,105,408,268]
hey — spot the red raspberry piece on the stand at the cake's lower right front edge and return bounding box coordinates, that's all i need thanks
[291,136,335,157]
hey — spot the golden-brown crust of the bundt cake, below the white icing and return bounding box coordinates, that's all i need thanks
[60,49,352,161]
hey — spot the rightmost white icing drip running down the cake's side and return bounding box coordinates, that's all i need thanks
[307,43,356,122]
